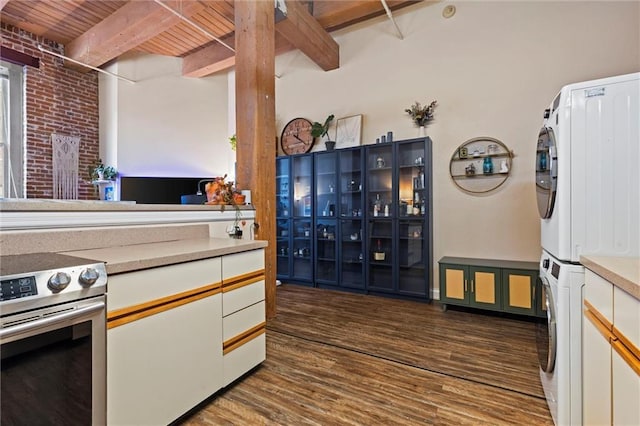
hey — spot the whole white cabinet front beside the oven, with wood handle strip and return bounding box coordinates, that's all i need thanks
[107,257,224,425]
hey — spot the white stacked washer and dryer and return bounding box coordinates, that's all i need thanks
[536,73,640,426]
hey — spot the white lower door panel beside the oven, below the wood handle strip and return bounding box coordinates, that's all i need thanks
[107,294,223,425]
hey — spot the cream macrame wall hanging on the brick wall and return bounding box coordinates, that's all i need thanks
[51,133,80,200]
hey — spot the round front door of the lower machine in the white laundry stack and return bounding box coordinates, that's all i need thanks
[536,277,558,373]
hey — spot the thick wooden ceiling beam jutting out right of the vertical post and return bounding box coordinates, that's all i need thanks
[275,0,340,71]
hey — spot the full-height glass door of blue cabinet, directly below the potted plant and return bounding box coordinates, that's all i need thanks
[315,151,338,285]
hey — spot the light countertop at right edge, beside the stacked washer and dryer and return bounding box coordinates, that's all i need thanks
[580,256,640,300]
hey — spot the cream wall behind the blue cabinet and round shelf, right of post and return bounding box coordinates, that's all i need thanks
[276,2,640,272]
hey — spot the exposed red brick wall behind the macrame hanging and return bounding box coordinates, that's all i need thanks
[1,23,99,200]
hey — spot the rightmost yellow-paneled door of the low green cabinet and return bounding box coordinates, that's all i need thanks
[502,269,538,315]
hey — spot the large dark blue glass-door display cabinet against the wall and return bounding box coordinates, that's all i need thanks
[276,138,432,300]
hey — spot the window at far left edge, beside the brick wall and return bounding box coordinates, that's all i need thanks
[0,61,25,198]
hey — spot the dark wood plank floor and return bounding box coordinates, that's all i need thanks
[184,285,553,425]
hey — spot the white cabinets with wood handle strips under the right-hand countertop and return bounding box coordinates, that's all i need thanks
[582,269,640,425]
